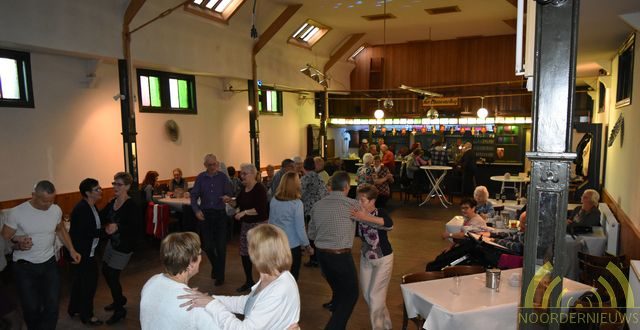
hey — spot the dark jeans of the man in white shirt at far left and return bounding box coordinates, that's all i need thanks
[13,257,60,330]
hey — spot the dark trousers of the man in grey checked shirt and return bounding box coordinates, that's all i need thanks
[316,251,359,330]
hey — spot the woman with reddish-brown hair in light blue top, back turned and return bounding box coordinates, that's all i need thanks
[269,172,313,281]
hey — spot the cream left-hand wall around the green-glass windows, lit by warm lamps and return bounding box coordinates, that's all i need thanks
[0,0,338,200]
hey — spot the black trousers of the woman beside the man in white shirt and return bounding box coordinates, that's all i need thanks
[67,256,98,320]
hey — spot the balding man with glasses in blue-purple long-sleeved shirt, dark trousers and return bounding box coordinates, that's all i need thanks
[191,154,233,286]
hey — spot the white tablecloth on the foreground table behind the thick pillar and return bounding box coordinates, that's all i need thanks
[400,268,592,329]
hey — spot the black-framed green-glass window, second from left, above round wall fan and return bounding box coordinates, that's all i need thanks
[136,68,198,115]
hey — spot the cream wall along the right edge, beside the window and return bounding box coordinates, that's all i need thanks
[593,31,640,228]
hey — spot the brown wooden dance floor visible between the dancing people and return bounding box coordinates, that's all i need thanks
[1,195,459,329]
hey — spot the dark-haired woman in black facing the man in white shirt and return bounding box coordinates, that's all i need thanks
[67,178,102,325]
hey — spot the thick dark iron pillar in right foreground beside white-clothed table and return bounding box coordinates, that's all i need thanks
[518,0,579,329]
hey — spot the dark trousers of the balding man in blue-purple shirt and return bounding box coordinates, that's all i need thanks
[199,210,228,281]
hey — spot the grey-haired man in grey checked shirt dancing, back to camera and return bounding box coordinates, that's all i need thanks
[309,171,360,329]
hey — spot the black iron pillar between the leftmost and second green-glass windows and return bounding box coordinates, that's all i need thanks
[118,60,138,191]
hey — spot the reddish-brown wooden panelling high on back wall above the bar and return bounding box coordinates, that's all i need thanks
[351,35,517,90]
